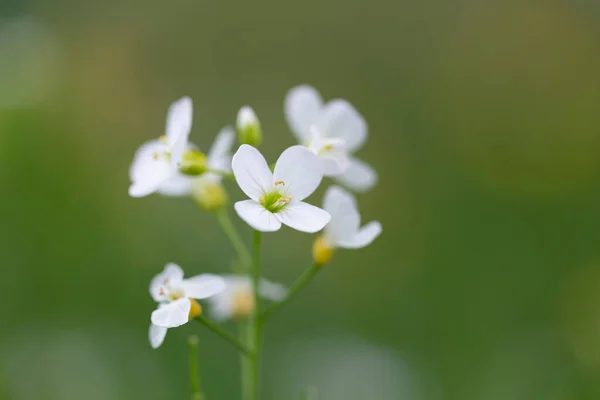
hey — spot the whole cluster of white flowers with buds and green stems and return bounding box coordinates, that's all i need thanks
[129,85,381,399]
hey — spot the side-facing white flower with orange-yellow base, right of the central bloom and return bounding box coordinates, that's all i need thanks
[313,186,381,264]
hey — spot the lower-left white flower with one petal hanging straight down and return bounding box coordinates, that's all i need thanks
[148,263,225,348]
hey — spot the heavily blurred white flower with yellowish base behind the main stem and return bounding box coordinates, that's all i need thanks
[209,275,287,320]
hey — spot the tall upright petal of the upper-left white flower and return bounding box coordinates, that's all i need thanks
[166,96,193,165]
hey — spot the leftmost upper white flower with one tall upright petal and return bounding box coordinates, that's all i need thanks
[129,97,192,197]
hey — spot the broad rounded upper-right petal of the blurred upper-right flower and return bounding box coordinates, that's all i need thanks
[316,99,367,152]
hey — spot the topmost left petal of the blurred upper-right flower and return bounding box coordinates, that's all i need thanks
[284,85,323,144]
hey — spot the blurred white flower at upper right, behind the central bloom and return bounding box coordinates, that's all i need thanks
[285,85,377,191]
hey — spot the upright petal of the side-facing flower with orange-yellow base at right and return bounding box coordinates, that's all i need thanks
[323,186,360,243]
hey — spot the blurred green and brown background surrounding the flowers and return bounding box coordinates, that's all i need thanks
[0,0,600,400]
